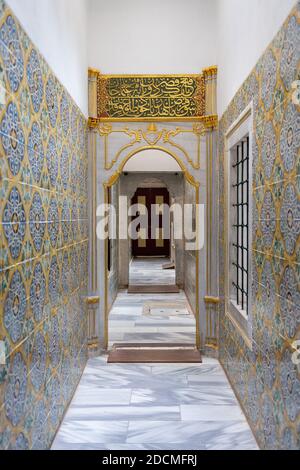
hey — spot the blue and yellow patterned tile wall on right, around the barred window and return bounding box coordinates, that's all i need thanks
[219,2,300,449]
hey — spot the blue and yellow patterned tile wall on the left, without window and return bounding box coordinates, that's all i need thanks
[0,0,88,449]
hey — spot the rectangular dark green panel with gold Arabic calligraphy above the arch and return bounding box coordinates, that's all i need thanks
[97,72,206,122]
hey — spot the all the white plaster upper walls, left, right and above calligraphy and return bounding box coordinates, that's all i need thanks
[7,0,296,116]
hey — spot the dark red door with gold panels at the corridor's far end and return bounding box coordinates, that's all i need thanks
[132,188,170,257]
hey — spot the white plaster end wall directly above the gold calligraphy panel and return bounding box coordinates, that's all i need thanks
[89,0,217,74]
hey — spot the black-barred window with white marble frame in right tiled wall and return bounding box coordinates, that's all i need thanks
[225,106,252,347]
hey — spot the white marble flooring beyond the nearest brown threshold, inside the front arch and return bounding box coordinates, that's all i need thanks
[109,258,196,346]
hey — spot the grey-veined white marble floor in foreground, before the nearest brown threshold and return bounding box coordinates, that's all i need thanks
[53,357,257,450]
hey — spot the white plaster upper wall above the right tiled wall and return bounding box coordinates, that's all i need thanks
[217,0,296,117]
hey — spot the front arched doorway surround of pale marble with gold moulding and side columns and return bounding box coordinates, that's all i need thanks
[89,67,219,351]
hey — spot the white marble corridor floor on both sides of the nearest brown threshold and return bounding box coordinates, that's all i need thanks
[53,258,257,450]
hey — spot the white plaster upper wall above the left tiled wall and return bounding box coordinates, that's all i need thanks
[7,0,88,116]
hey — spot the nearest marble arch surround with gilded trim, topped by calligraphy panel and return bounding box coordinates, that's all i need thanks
[89,67,218,349]
